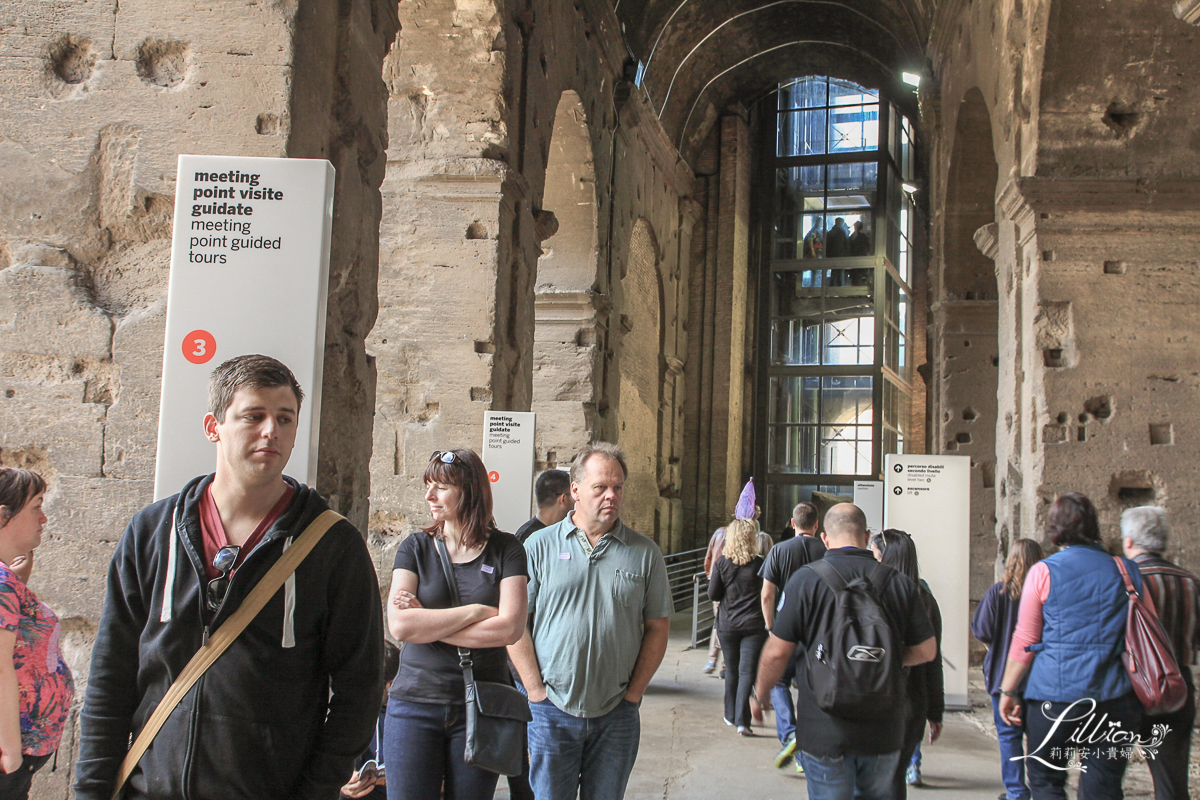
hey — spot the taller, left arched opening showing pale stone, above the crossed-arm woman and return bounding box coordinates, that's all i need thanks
[532,90,600,469]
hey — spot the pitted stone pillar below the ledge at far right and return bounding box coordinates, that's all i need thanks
[1019,179,1200,570]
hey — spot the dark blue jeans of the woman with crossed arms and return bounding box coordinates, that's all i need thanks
[383,697,499,800]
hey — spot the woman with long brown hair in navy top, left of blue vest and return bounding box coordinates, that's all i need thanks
[971,539,1044,800]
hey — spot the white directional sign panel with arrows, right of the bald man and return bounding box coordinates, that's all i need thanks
[884,455,971,708]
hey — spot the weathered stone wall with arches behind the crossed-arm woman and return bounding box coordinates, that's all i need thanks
[370,0,690,556]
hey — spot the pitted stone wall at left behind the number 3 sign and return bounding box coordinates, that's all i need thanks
[0,0,396,798]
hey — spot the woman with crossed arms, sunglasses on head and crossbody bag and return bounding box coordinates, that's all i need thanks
[384,450,529,800]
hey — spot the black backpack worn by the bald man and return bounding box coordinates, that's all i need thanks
[804,560,905,720]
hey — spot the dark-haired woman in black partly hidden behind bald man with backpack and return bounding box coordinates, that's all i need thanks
[870,528,946,800]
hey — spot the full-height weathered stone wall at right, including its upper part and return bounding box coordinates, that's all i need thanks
[923,1,1200,623]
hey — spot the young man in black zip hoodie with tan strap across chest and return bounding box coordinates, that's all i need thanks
[76,355,383,800]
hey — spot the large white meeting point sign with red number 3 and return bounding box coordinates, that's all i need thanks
[154,156,334,499]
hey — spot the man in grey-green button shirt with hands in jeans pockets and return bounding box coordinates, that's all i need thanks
[509,443,672,800]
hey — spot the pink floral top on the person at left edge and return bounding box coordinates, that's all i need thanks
[0,561,74,756]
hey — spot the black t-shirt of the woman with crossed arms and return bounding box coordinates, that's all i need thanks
[389,531,529,703]
